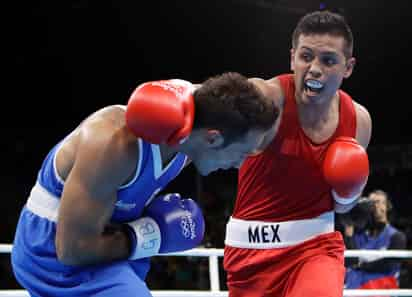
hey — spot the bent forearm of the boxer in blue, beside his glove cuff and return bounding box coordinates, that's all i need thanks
[58,226,130,266]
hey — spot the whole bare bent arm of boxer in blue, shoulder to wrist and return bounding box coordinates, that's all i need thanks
[56,123,136,265]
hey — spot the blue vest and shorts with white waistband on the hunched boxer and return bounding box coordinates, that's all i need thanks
[11,132,187,297]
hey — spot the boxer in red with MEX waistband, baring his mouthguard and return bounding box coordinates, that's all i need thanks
[224,11,371,297]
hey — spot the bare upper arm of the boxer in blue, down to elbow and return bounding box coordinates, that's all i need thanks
[57,127,131,241]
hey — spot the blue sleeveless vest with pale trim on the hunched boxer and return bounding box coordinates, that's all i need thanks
[37,135,187,223]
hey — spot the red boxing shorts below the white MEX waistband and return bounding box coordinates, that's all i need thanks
[224,232,345,297]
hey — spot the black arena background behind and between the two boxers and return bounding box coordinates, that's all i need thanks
[0,0,412,290]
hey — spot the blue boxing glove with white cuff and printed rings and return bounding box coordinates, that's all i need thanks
[127,194,205,260]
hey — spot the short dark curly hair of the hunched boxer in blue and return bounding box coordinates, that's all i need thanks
[193,72,279,145]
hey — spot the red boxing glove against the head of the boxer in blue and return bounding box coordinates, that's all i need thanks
[126,79,195,145]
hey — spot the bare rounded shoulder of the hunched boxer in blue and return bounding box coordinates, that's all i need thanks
[51,106,139,193]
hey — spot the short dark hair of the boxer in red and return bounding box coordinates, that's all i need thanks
[292,10,353,58]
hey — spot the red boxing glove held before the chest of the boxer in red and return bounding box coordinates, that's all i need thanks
[323,137,369,204]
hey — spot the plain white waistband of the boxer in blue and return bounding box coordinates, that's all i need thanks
[26,183,60,222]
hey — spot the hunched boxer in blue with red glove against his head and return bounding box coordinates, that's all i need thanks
[12,73,278,297]
